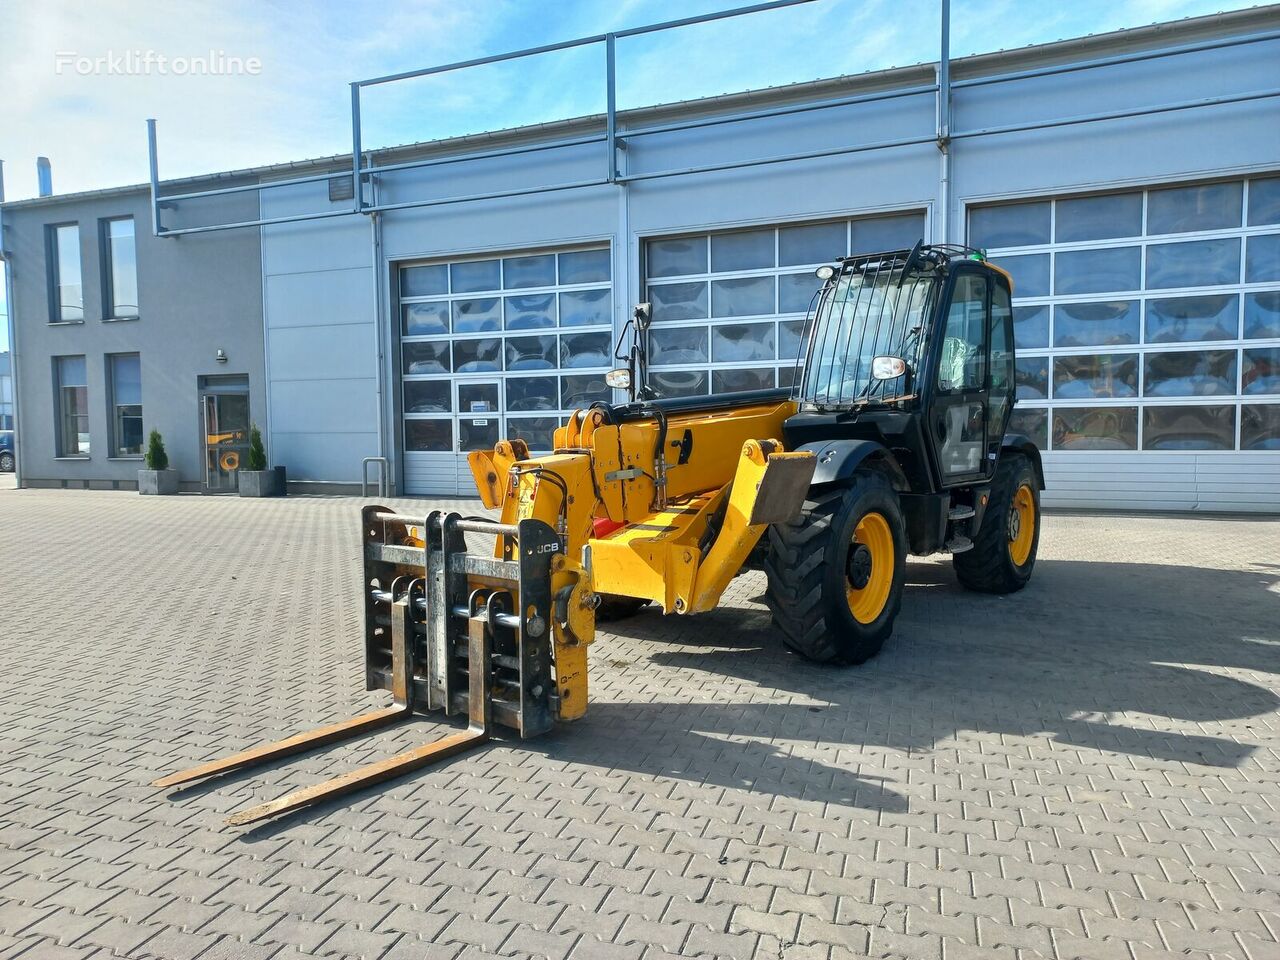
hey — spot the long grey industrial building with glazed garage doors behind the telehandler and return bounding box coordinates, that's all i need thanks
[0,5,1280,512]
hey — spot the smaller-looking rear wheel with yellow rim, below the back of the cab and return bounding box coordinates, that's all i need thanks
[951,453,1041,594]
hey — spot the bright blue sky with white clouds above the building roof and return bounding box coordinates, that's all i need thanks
[0,0,1249,348]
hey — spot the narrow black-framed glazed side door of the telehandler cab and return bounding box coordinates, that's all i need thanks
[928,264,988,486]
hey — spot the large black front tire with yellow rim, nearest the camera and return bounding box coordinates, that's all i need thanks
[764,471,908,664]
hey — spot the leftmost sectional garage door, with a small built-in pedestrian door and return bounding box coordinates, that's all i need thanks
[398,247,613,497]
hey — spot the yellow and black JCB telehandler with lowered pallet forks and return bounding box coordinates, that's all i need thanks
[156,243,1043,823]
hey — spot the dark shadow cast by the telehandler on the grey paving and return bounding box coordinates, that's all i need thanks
[537,561,1280,809]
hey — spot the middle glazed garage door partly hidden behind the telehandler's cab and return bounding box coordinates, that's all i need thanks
[644,211,925,397]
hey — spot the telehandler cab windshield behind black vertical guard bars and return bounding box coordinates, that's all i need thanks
[800,264,936,406]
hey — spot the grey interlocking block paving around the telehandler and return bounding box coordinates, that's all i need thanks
[0,490,1280,960]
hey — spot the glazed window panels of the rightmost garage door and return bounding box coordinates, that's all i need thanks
[969,175,1280,451]
